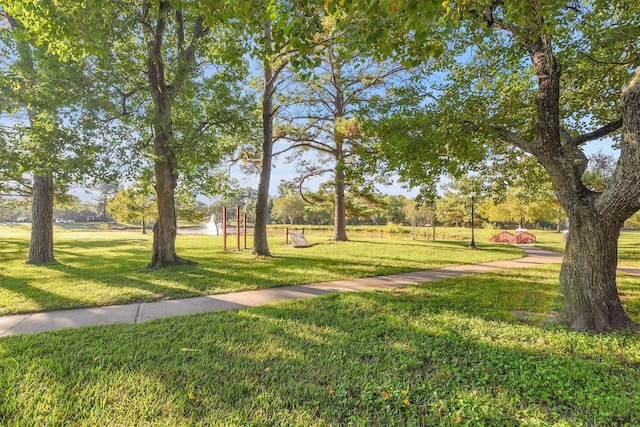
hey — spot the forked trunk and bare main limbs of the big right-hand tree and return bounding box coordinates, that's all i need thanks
[523,36,640,332]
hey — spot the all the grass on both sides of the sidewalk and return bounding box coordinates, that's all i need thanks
[0,225,640,427]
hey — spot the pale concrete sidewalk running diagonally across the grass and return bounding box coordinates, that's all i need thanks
[0,246,592,337]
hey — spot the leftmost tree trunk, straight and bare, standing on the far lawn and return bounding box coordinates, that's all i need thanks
[27,175,55,264]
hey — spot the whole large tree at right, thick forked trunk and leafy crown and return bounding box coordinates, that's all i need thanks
[334,0,640,332]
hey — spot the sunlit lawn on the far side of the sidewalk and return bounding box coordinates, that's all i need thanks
[0,224,522,315]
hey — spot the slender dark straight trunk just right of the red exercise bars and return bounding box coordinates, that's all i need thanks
[253,29,275,256]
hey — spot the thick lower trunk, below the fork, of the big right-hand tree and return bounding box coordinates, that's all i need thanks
[559,208,633,332]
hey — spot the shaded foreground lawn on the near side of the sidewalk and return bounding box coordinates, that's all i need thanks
[0,266,640,426]
